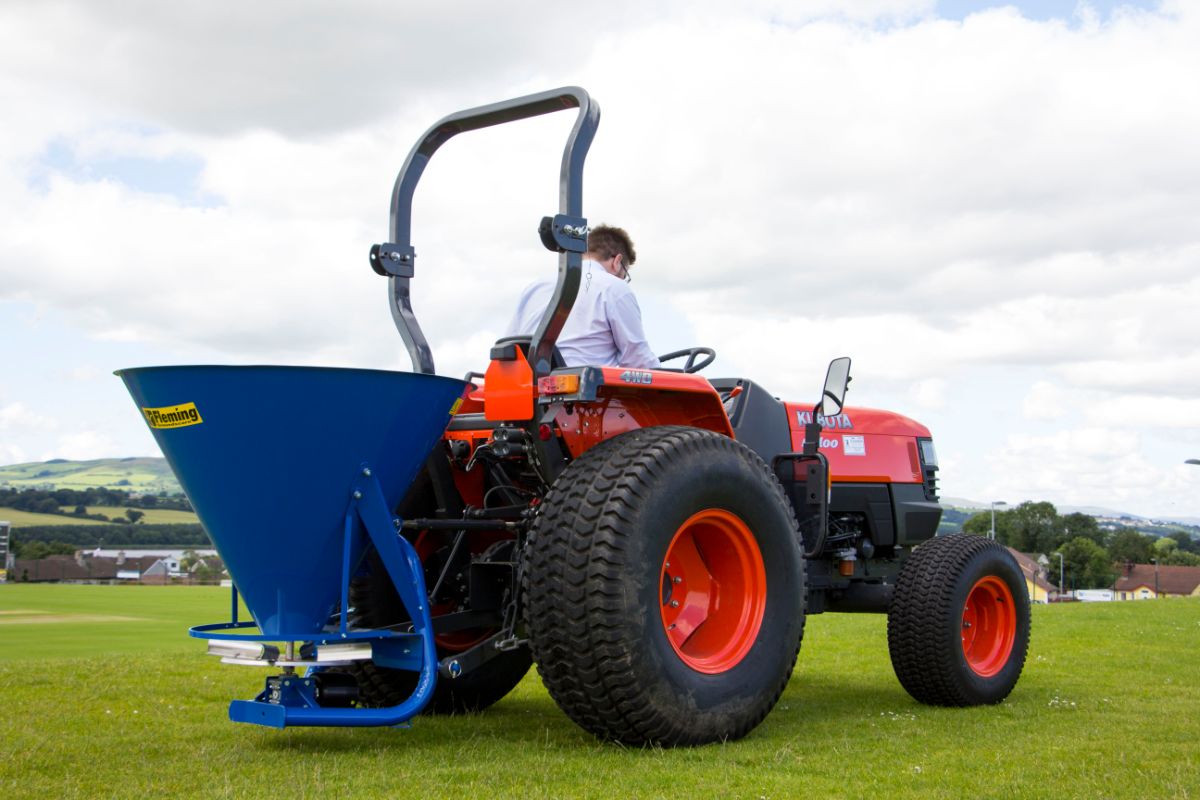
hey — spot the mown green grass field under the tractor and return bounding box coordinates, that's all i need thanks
[0,585,1200,800]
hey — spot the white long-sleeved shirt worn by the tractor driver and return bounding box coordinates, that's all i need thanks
[505,259,660,369]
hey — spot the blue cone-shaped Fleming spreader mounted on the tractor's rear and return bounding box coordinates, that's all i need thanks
[118,366,466,728]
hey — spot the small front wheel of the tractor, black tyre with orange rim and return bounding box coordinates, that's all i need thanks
[888,535,1030,705]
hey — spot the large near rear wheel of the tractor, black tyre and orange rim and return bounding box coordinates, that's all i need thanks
[523,427,805,746]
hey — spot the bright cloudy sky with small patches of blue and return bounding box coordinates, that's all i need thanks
[0,0,1200,517]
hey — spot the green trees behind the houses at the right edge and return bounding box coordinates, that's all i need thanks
[962,503,1200,589]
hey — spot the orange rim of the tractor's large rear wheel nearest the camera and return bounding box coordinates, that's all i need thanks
[659,509,767,675]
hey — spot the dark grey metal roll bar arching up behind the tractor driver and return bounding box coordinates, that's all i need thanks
[371,86,600,378]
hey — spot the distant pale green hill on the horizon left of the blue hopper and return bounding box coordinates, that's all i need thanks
[0,458,182,495]
